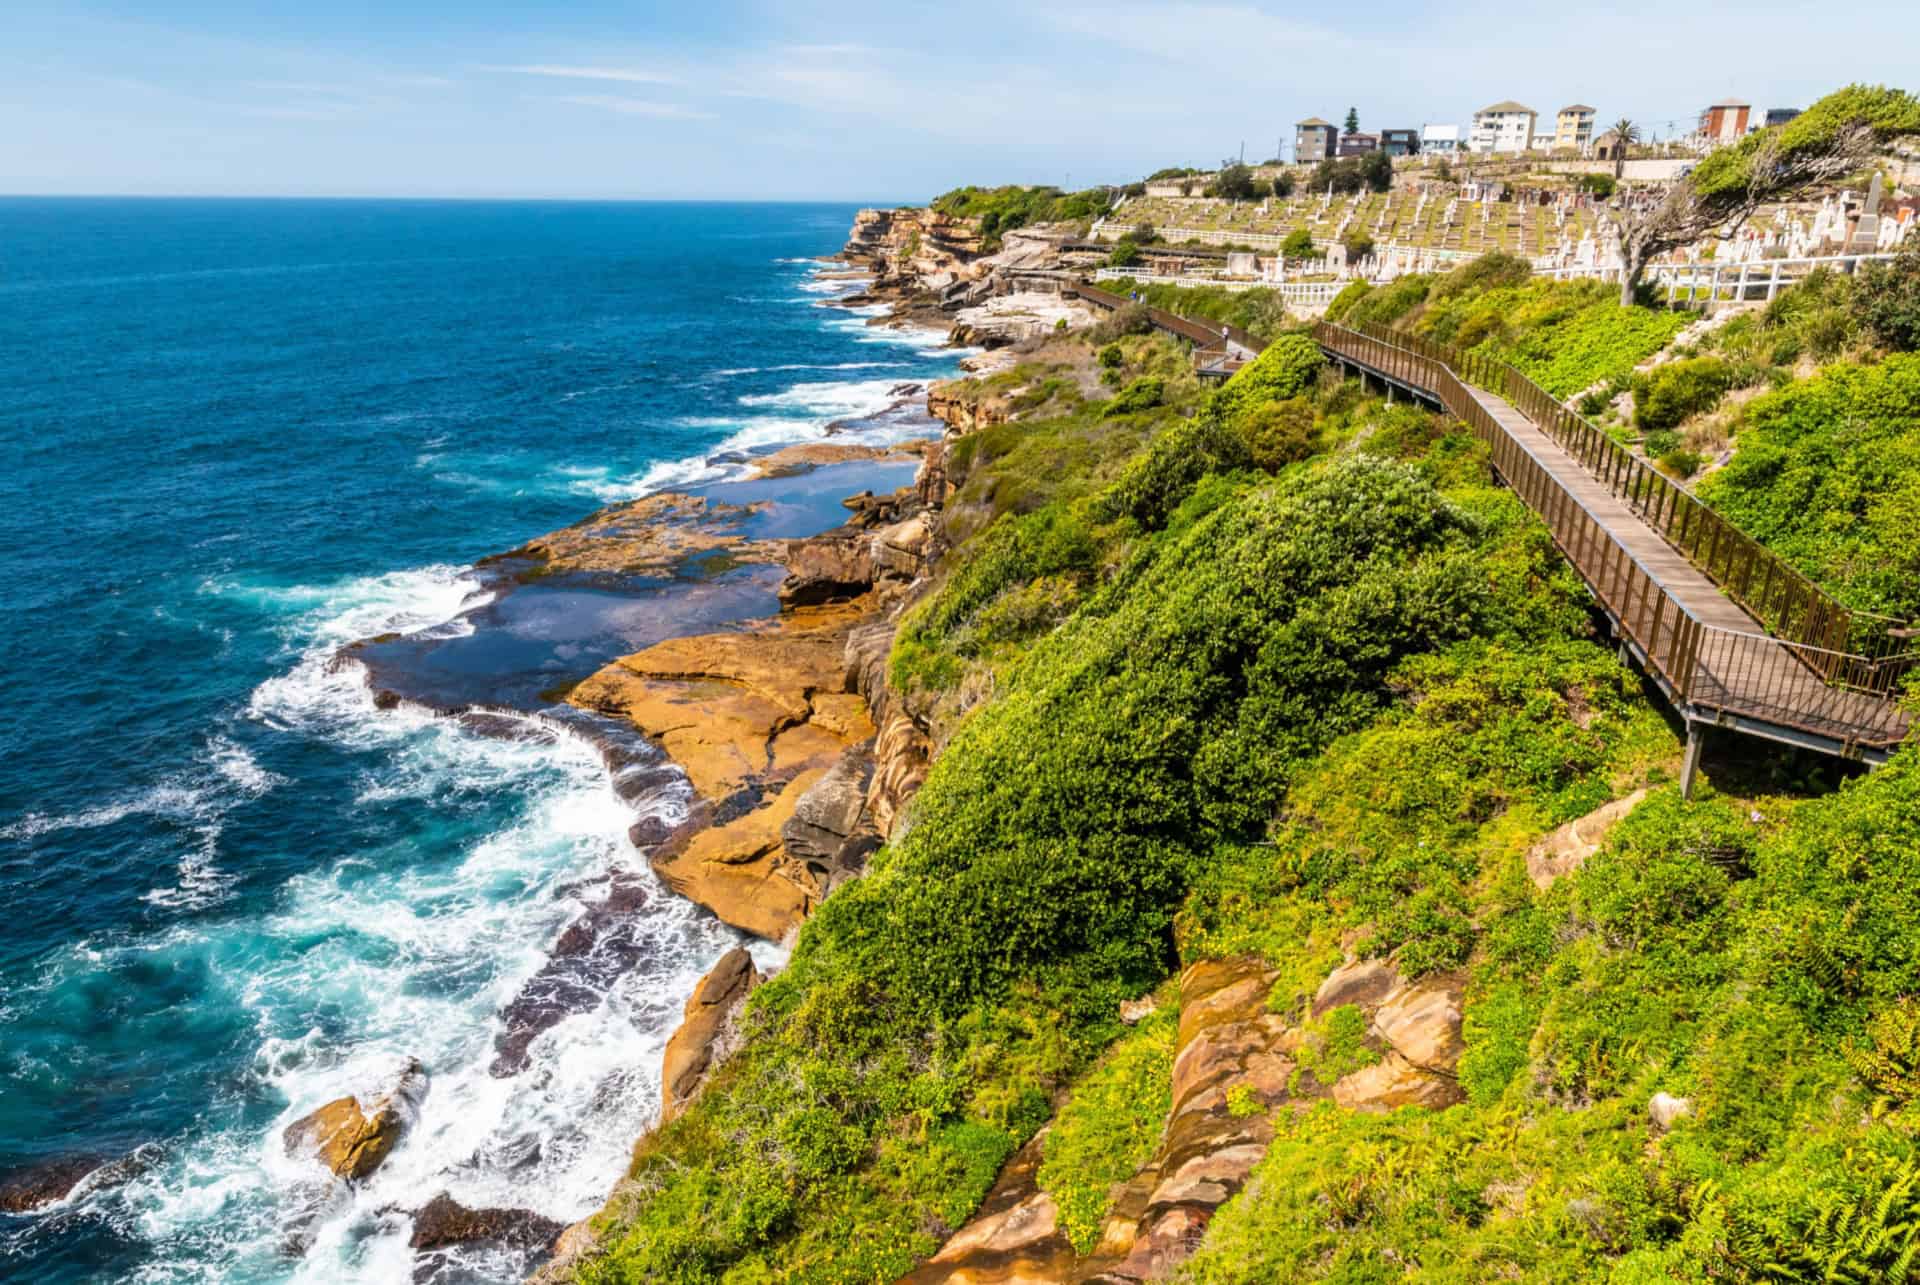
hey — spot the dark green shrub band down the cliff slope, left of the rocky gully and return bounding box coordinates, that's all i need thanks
[584,305,1651,1281]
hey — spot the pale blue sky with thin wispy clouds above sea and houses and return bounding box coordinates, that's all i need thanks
[0,0,1920,202]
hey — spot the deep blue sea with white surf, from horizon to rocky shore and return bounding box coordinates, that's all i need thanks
[0,200,954,1281]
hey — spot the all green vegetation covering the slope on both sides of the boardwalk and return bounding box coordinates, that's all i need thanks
[580,238,1920,1285]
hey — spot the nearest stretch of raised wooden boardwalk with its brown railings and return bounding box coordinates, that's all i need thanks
[1315,323,1920,786]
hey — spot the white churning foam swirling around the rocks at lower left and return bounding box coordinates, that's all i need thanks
[67,567,741,1285]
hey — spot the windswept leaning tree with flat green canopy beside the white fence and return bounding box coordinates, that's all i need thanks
[1613,85,1920,303]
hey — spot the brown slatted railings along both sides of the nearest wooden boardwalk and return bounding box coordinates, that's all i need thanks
[1313,323,1920,749]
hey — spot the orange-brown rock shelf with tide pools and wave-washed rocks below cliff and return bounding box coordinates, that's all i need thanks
[232,240,1021,1275]
